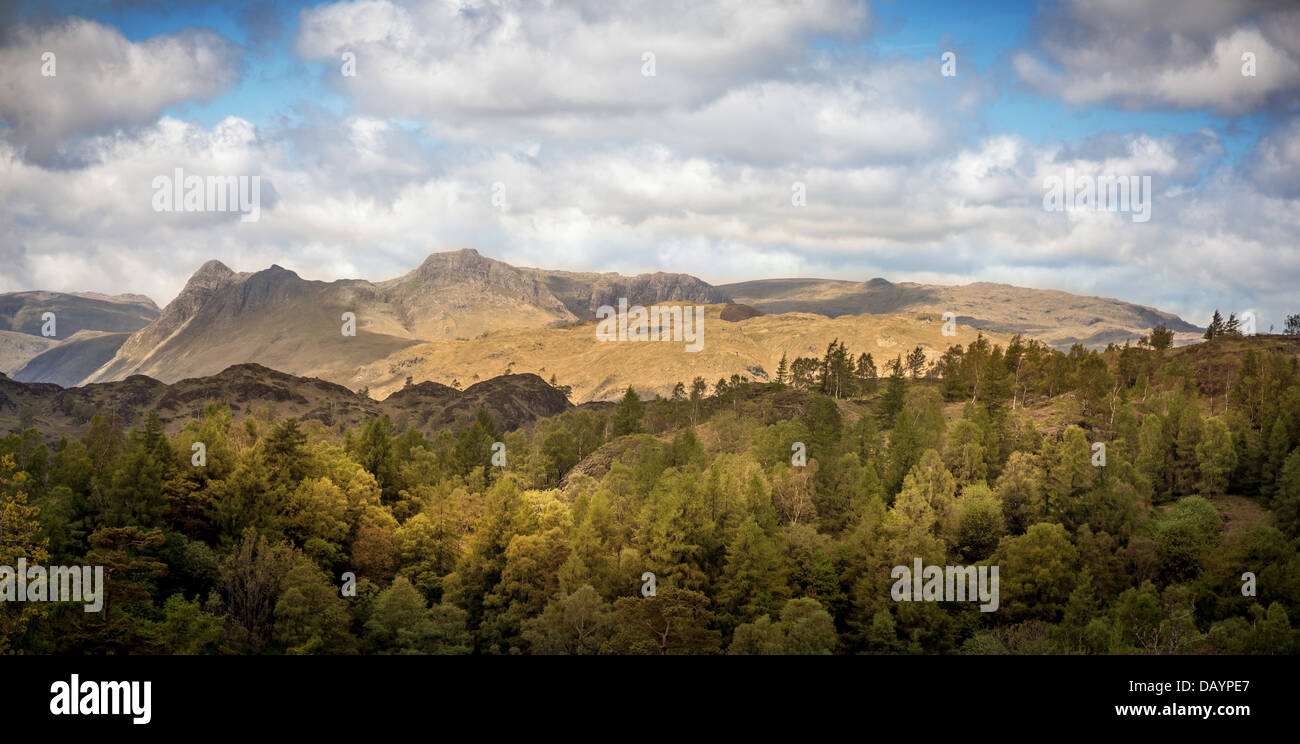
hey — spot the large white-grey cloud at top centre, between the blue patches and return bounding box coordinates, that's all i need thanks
[296,0,987,165]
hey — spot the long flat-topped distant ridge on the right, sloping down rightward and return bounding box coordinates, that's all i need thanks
[718,278,1204,350]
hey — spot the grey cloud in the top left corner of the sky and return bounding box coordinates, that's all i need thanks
[0,18,241,164]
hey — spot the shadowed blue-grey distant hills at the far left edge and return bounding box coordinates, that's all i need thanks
[0,291,159,382]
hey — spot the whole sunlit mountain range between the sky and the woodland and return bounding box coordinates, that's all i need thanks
[0,250,1200,401]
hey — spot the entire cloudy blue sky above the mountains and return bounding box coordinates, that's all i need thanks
[0,0,1300,330]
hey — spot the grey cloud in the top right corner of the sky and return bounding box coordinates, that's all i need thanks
[1011,0,1300,116]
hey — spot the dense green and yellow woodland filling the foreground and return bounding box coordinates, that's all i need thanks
[0,329,1300,654]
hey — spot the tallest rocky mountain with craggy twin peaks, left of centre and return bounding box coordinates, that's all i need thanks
[78,250,720,388]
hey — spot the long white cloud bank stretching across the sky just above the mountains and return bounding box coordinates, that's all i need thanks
[0,102,1300,331]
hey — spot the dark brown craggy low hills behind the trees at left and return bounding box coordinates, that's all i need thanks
[0,364,572,438]
